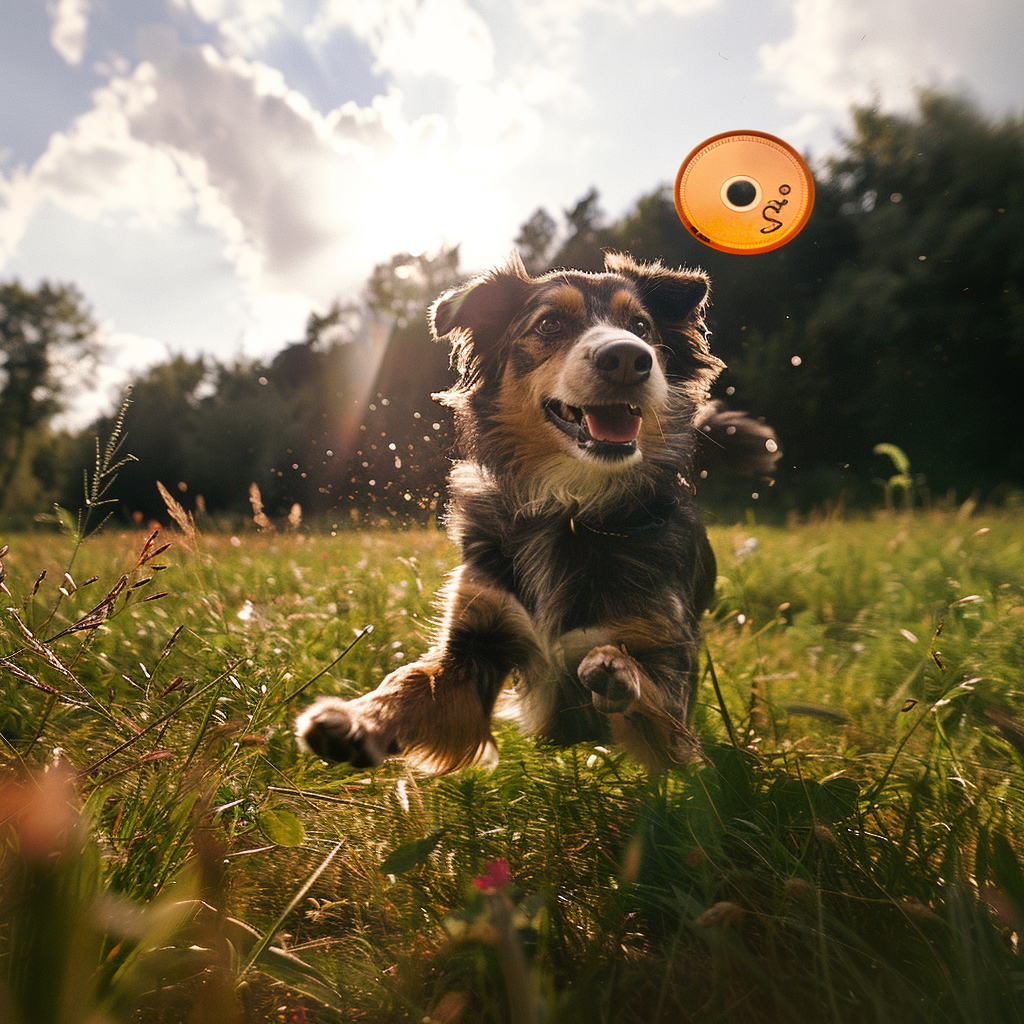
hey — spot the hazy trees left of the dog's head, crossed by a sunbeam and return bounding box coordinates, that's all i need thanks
[60,243,460,521]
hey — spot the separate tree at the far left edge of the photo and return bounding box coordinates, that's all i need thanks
[0,281,96,508]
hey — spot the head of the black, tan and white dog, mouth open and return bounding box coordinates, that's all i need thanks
[430,255,723,505]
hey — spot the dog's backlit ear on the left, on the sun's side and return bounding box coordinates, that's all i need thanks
[428,253,530,378]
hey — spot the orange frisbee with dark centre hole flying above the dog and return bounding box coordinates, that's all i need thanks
[675,131,814,253]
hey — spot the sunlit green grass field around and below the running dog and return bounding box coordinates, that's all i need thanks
[0,509,1024,1024]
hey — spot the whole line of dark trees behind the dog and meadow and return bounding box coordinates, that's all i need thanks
[0,92,1024,524]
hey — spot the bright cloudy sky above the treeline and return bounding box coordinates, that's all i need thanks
[0,0,1024,422]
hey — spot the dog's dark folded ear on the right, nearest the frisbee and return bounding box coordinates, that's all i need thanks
[604,253,725,399]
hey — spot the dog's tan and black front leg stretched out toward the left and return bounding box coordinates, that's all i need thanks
[296,565,541,772]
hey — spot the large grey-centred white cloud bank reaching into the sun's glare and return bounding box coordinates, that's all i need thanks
[0,36,512,335]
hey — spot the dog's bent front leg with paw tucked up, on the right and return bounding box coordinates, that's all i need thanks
[579,644,700,770]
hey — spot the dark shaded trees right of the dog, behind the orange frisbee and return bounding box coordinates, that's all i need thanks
[552,92,1024,509]
